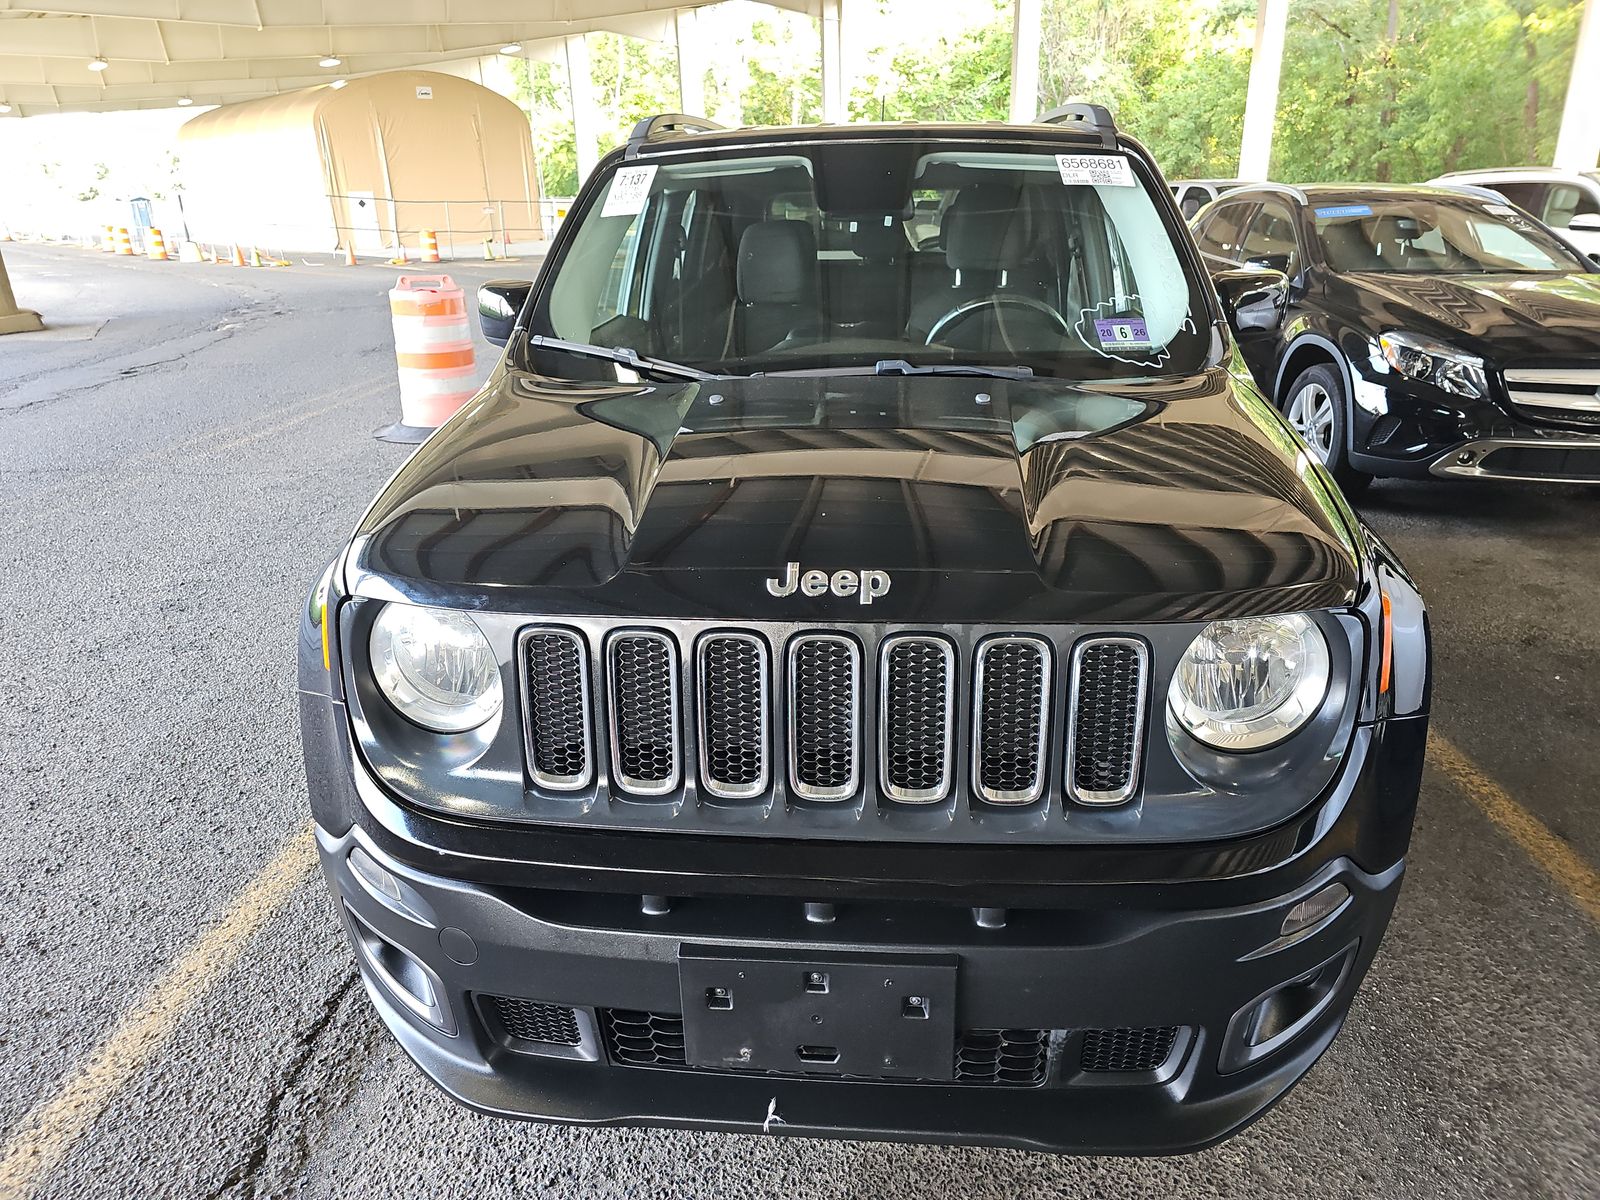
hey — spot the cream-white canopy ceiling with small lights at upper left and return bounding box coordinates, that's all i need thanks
[0,0,821,115]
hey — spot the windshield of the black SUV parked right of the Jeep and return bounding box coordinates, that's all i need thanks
[1312,197,1589,275]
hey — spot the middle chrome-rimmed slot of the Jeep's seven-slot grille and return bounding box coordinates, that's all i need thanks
[789,634,861,800]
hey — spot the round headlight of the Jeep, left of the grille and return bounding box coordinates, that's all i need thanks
[371,603,502,733]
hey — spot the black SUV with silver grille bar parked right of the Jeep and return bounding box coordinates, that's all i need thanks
[1192,184,1600,491]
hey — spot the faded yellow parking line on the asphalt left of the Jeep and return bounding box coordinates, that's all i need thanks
[0,827,317,1200]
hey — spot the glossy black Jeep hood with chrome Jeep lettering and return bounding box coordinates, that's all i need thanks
[346,368,1360,622]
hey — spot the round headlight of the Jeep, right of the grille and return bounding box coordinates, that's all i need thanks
[1168,613,1328,750]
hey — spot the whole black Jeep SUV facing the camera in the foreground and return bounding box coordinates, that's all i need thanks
[301,106,1429,1154]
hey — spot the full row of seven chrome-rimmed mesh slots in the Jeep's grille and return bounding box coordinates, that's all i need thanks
[522,626,1150,805]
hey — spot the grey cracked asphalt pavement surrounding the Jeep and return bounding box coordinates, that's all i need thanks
[0,245,1600,1200]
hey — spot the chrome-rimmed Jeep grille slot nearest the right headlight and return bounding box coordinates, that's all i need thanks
[1067,637,1150,805]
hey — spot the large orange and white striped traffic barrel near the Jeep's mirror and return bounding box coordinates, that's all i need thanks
[389,275,478,429]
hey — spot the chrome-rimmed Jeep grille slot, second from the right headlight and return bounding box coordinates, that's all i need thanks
[973,635,1050,805]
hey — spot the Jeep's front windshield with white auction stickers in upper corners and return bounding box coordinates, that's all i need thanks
[530,138,1210,379]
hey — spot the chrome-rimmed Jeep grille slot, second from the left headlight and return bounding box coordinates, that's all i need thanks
[606,630,680,795]
